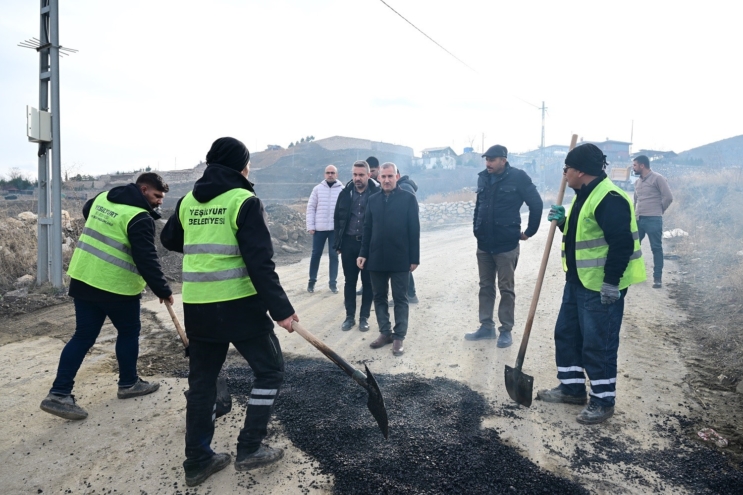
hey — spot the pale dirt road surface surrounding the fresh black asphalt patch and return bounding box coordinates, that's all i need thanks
[0,219,736,494]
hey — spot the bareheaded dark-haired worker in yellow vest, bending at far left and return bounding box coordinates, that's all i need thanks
[41,173,173,419]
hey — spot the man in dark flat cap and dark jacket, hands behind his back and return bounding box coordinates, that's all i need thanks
[464,144,542,347]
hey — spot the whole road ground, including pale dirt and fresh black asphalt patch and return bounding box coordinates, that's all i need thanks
[0,219,743,494]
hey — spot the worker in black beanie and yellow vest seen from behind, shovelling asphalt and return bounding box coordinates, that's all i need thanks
[160,137,299,486]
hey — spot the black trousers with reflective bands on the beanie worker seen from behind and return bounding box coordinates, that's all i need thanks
[183,332,284,471]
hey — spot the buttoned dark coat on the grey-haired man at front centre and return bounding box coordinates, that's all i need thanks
[359,187,421,272]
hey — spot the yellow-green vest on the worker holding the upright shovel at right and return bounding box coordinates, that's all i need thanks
[562,178,647,292]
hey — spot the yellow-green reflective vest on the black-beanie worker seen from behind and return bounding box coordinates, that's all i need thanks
[178,189,257,304]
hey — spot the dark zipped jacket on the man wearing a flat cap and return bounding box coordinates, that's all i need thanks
[472,162,543,254]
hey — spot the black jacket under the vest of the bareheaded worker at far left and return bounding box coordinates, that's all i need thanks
[70,184,173,302]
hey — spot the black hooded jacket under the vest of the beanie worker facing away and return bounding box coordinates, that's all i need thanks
[160,164,294,342]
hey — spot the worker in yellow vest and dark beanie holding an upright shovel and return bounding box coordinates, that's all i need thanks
[537,143,645,425]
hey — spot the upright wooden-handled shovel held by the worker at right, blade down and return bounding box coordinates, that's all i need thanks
[505,134,578,407]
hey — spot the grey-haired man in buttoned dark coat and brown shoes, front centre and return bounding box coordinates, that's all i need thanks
[357,162,420,356]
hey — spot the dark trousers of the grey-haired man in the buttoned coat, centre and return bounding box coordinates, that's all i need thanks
[371,271,410,340]
